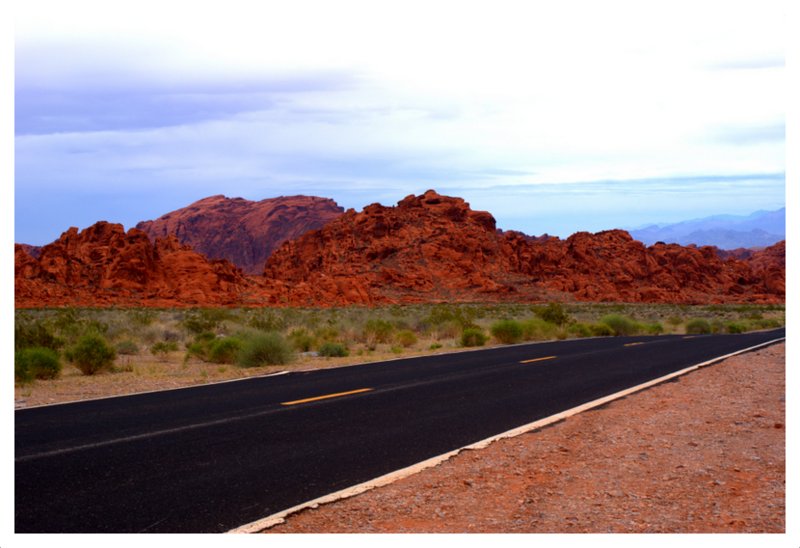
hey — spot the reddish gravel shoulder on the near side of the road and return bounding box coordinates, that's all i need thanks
[265,343,786,533]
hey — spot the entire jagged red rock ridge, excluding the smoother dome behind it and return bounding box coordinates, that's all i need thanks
[15,190,786,307]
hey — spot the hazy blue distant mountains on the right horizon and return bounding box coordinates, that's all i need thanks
[629,208,786,249]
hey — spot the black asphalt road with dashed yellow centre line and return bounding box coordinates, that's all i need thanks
[15,329,785,533]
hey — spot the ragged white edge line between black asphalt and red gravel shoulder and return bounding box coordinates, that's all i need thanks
[228,337,786,534]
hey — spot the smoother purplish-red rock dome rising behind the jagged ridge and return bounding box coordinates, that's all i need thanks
[136,195,344,274]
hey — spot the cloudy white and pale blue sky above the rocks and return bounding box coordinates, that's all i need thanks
[14,0,785,245]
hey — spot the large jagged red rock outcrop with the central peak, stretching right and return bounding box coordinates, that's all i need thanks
[264,191,784,305]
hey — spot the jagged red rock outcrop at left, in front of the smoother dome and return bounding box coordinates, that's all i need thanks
[15,221,252,307]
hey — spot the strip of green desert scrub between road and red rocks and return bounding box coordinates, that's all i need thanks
[14,303,785,400]
